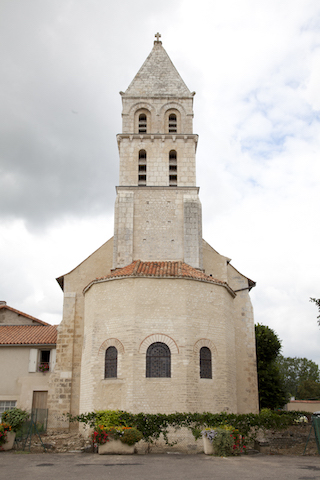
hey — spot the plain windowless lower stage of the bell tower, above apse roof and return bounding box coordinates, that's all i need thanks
[113,187,202,268]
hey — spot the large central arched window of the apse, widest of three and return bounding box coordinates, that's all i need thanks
[146,342,171,377]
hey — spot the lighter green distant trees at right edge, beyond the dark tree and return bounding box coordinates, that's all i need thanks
[276,355,320,398]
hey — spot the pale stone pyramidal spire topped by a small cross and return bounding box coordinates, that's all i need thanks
[124,33,192,97]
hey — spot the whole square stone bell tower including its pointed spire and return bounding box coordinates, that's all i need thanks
[113,34,202,269]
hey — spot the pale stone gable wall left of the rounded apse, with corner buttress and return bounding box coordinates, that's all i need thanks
[48,238,113,430]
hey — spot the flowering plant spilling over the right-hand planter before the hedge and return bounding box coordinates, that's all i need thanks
[201,425,246,456]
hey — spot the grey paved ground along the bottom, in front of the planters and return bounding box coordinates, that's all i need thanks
[0,452,320,480]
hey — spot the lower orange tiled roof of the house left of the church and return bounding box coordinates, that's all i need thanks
[0,324,57,345]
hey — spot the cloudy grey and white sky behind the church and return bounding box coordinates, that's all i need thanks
[0,0,320,365]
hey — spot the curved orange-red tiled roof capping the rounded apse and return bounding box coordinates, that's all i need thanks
[83,260,235,296]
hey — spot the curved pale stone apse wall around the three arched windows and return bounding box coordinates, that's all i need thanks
[80,278,237,413]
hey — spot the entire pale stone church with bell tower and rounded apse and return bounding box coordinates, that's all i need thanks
[48,34,258,430]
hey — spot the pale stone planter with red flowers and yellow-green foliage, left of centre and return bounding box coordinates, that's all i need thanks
[92,425,142,455]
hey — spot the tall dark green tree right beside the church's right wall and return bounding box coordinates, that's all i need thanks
[255,323,287,410]
